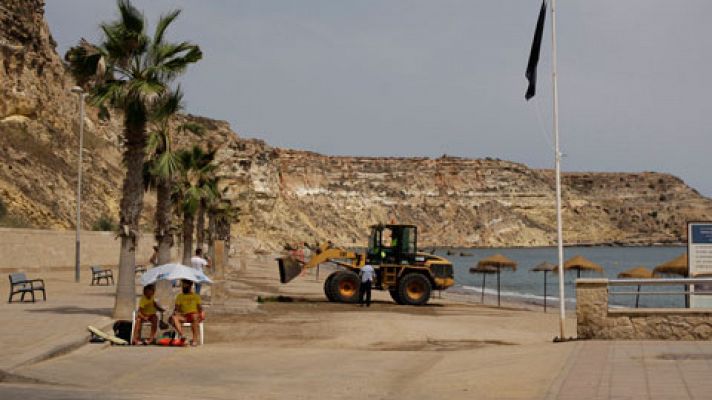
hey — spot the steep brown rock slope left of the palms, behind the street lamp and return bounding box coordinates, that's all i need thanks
[0,0,122,228]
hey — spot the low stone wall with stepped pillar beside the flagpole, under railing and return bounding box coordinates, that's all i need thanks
[576,279,712,340]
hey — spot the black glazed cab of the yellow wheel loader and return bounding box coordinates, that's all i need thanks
[368,225,418,265]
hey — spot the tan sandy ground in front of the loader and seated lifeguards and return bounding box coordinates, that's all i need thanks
[9,257,575,399]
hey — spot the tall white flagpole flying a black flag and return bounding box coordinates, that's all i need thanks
[551,0,566,340]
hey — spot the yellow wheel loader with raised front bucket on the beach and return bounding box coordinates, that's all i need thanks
[278,225,455,305]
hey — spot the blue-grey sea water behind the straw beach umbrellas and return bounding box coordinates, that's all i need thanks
[435,247,687,308]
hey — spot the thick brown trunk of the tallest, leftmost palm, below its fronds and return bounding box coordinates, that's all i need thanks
[113,113,146,319]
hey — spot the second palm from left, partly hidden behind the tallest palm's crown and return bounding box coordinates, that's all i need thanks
[144,87,204,264]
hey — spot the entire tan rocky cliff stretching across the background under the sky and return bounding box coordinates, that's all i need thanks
[0,0,712,246]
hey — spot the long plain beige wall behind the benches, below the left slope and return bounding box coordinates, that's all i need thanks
[0,228,154,273]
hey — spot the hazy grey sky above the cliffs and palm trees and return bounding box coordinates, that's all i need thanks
[46,0,712,196]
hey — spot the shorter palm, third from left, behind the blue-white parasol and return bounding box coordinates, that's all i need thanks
[174,146,216,264]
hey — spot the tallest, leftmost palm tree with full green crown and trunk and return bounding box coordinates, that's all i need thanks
[65,0,202,319]
